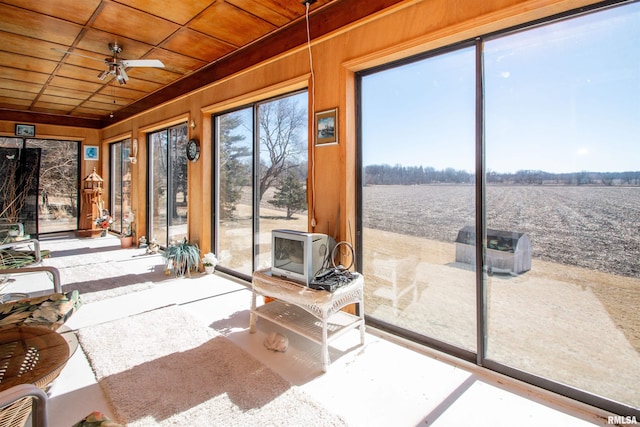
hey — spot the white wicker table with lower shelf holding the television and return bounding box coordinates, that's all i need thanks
[249,270,364,372]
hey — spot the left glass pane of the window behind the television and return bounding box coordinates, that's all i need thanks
[215,108,253,275]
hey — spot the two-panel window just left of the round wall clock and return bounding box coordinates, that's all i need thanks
[147,123,188,246]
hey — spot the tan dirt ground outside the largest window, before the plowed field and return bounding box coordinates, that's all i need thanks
[364,229,640,407]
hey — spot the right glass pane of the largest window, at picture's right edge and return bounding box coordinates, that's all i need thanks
[484,3,640,407]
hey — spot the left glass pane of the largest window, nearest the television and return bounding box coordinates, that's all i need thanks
[362,48,476,351]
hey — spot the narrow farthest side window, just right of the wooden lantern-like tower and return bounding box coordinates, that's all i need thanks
[109,139,135,233]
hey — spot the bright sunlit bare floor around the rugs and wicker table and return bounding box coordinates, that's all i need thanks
[16,236,609,427]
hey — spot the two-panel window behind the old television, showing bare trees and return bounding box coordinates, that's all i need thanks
[212,91,308,276]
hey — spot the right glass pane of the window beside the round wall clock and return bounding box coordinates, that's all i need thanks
[168,125,188,241]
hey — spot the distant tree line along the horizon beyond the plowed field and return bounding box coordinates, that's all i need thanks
[364,165,640,186]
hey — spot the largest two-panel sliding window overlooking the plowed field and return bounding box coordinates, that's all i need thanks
[359,2,640,415]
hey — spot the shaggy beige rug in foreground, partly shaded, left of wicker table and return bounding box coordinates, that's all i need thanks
[78,306,346,426]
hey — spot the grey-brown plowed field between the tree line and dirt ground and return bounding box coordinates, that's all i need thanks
[364,185,640,278]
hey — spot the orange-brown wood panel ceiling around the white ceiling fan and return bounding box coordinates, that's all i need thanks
[0,0,400,128]
